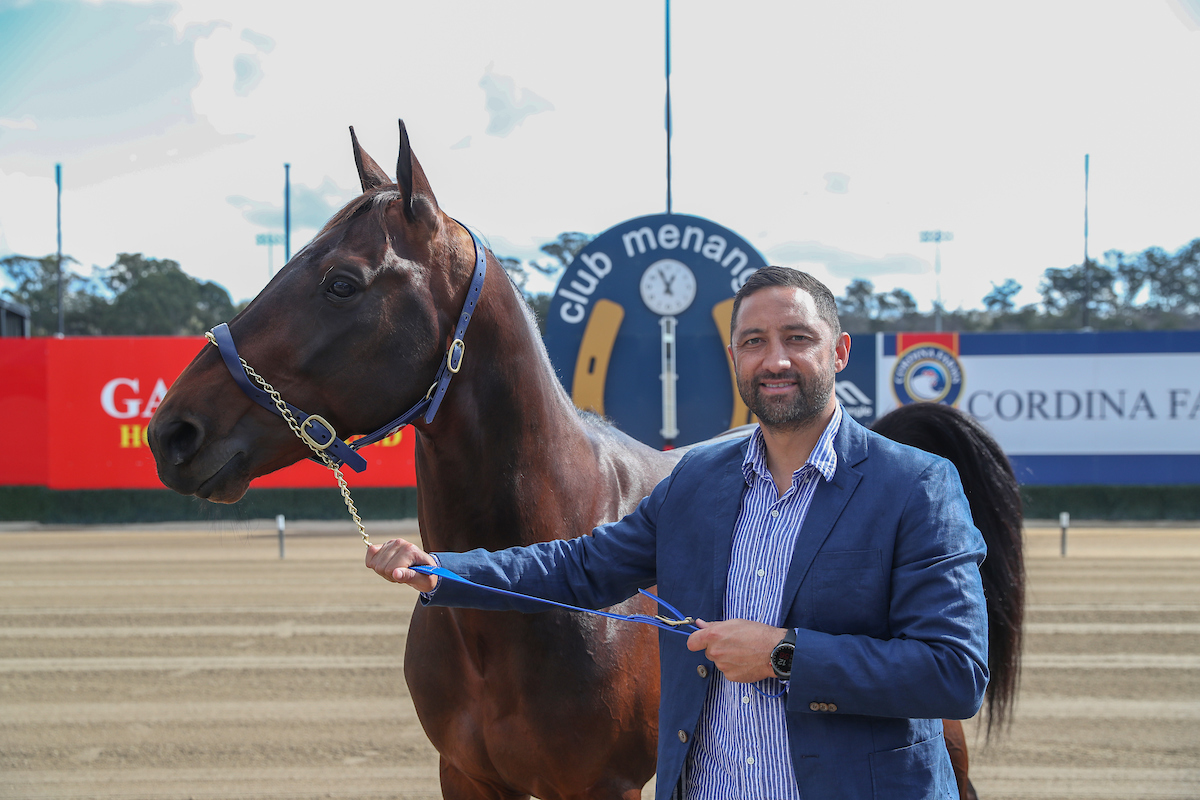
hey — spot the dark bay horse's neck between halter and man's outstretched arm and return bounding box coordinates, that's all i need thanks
[416,276,612,551]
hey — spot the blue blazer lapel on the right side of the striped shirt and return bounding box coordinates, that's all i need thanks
[782,413,866,624]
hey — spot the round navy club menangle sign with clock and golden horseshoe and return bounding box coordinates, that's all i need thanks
[546,213,766,447]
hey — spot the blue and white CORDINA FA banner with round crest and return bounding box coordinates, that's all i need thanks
[854,331,1200,486]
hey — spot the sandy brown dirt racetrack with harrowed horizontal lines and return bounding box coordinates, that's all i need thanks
[0,522,1200,800]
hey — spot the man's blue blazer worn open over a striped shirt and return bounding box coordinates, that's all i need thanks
[432,414,988,800]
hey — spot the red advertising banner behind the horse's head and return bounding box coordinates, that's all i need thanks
[0,336,416,489]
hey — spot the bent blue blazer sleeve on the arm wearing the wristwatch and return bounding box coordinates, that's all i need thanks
[788,459,988,720]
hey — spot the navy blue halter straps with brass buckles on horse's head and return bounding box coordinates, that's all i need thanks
[209,219,487,473]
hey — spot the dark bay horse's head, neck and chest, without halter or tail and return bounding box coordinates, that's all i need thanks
[149,122,678,800]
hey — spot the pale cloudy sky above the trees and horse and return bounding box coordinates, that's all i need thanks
[0,0,1200,309]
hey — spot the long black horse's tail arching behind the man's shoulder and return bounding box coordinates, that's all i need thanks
[872,403,1025,736]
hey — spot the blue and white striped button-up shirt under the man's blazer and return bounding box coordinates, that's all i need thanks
[683,405,841,800]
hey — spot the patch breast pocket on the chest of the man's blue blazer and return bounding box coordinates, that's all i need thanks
[810,549,888,634]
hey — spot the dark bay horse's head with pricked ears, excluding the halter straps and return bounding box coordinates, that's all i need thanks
[149,121,474,503]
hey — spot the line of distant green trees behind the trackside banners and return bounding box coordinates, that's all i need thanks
[0,231,1200,336]
